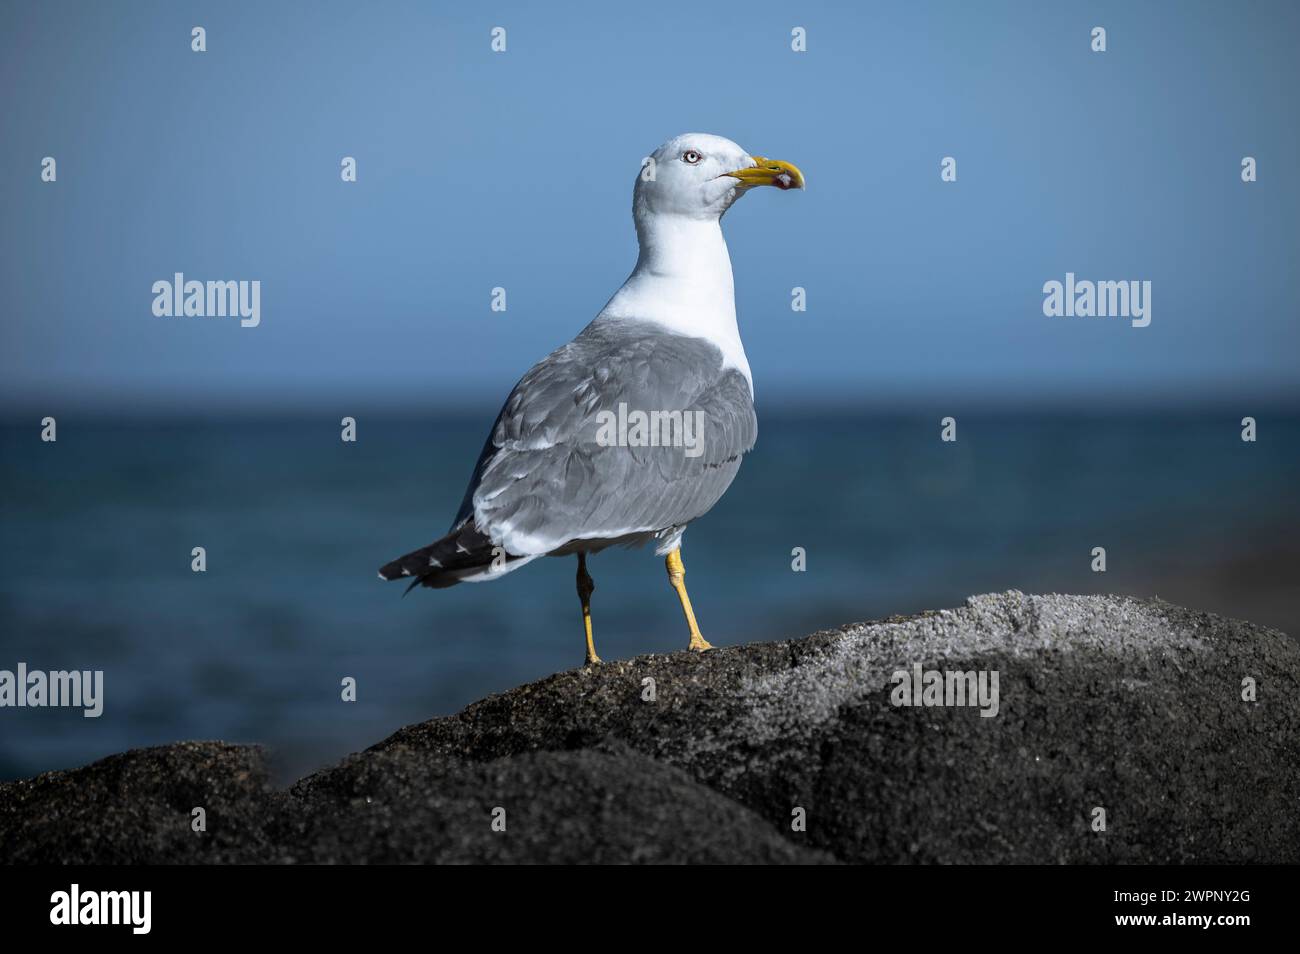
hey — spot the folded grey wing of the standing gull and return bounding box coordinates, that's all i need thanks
[454,320,758,555]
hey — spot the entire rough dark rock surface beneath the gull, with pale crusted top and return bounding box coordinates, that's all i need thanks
[0,591,1300,863]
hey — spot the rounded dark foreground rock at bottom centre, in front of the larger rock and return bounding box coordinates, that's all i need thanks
[289,746,835,864]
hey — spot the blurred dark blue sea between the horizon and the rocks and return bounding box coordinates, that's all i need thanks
[0,408,1300,780]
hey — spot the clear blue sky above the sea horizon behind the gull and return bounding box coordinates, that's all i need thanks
[0,0,1300,412]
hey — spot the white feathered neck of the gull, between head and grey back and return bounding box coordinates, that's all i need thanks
[597,214,754,393]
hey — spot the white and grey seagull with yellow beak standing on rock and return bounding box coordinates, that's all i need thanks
[380,133,803,665]
